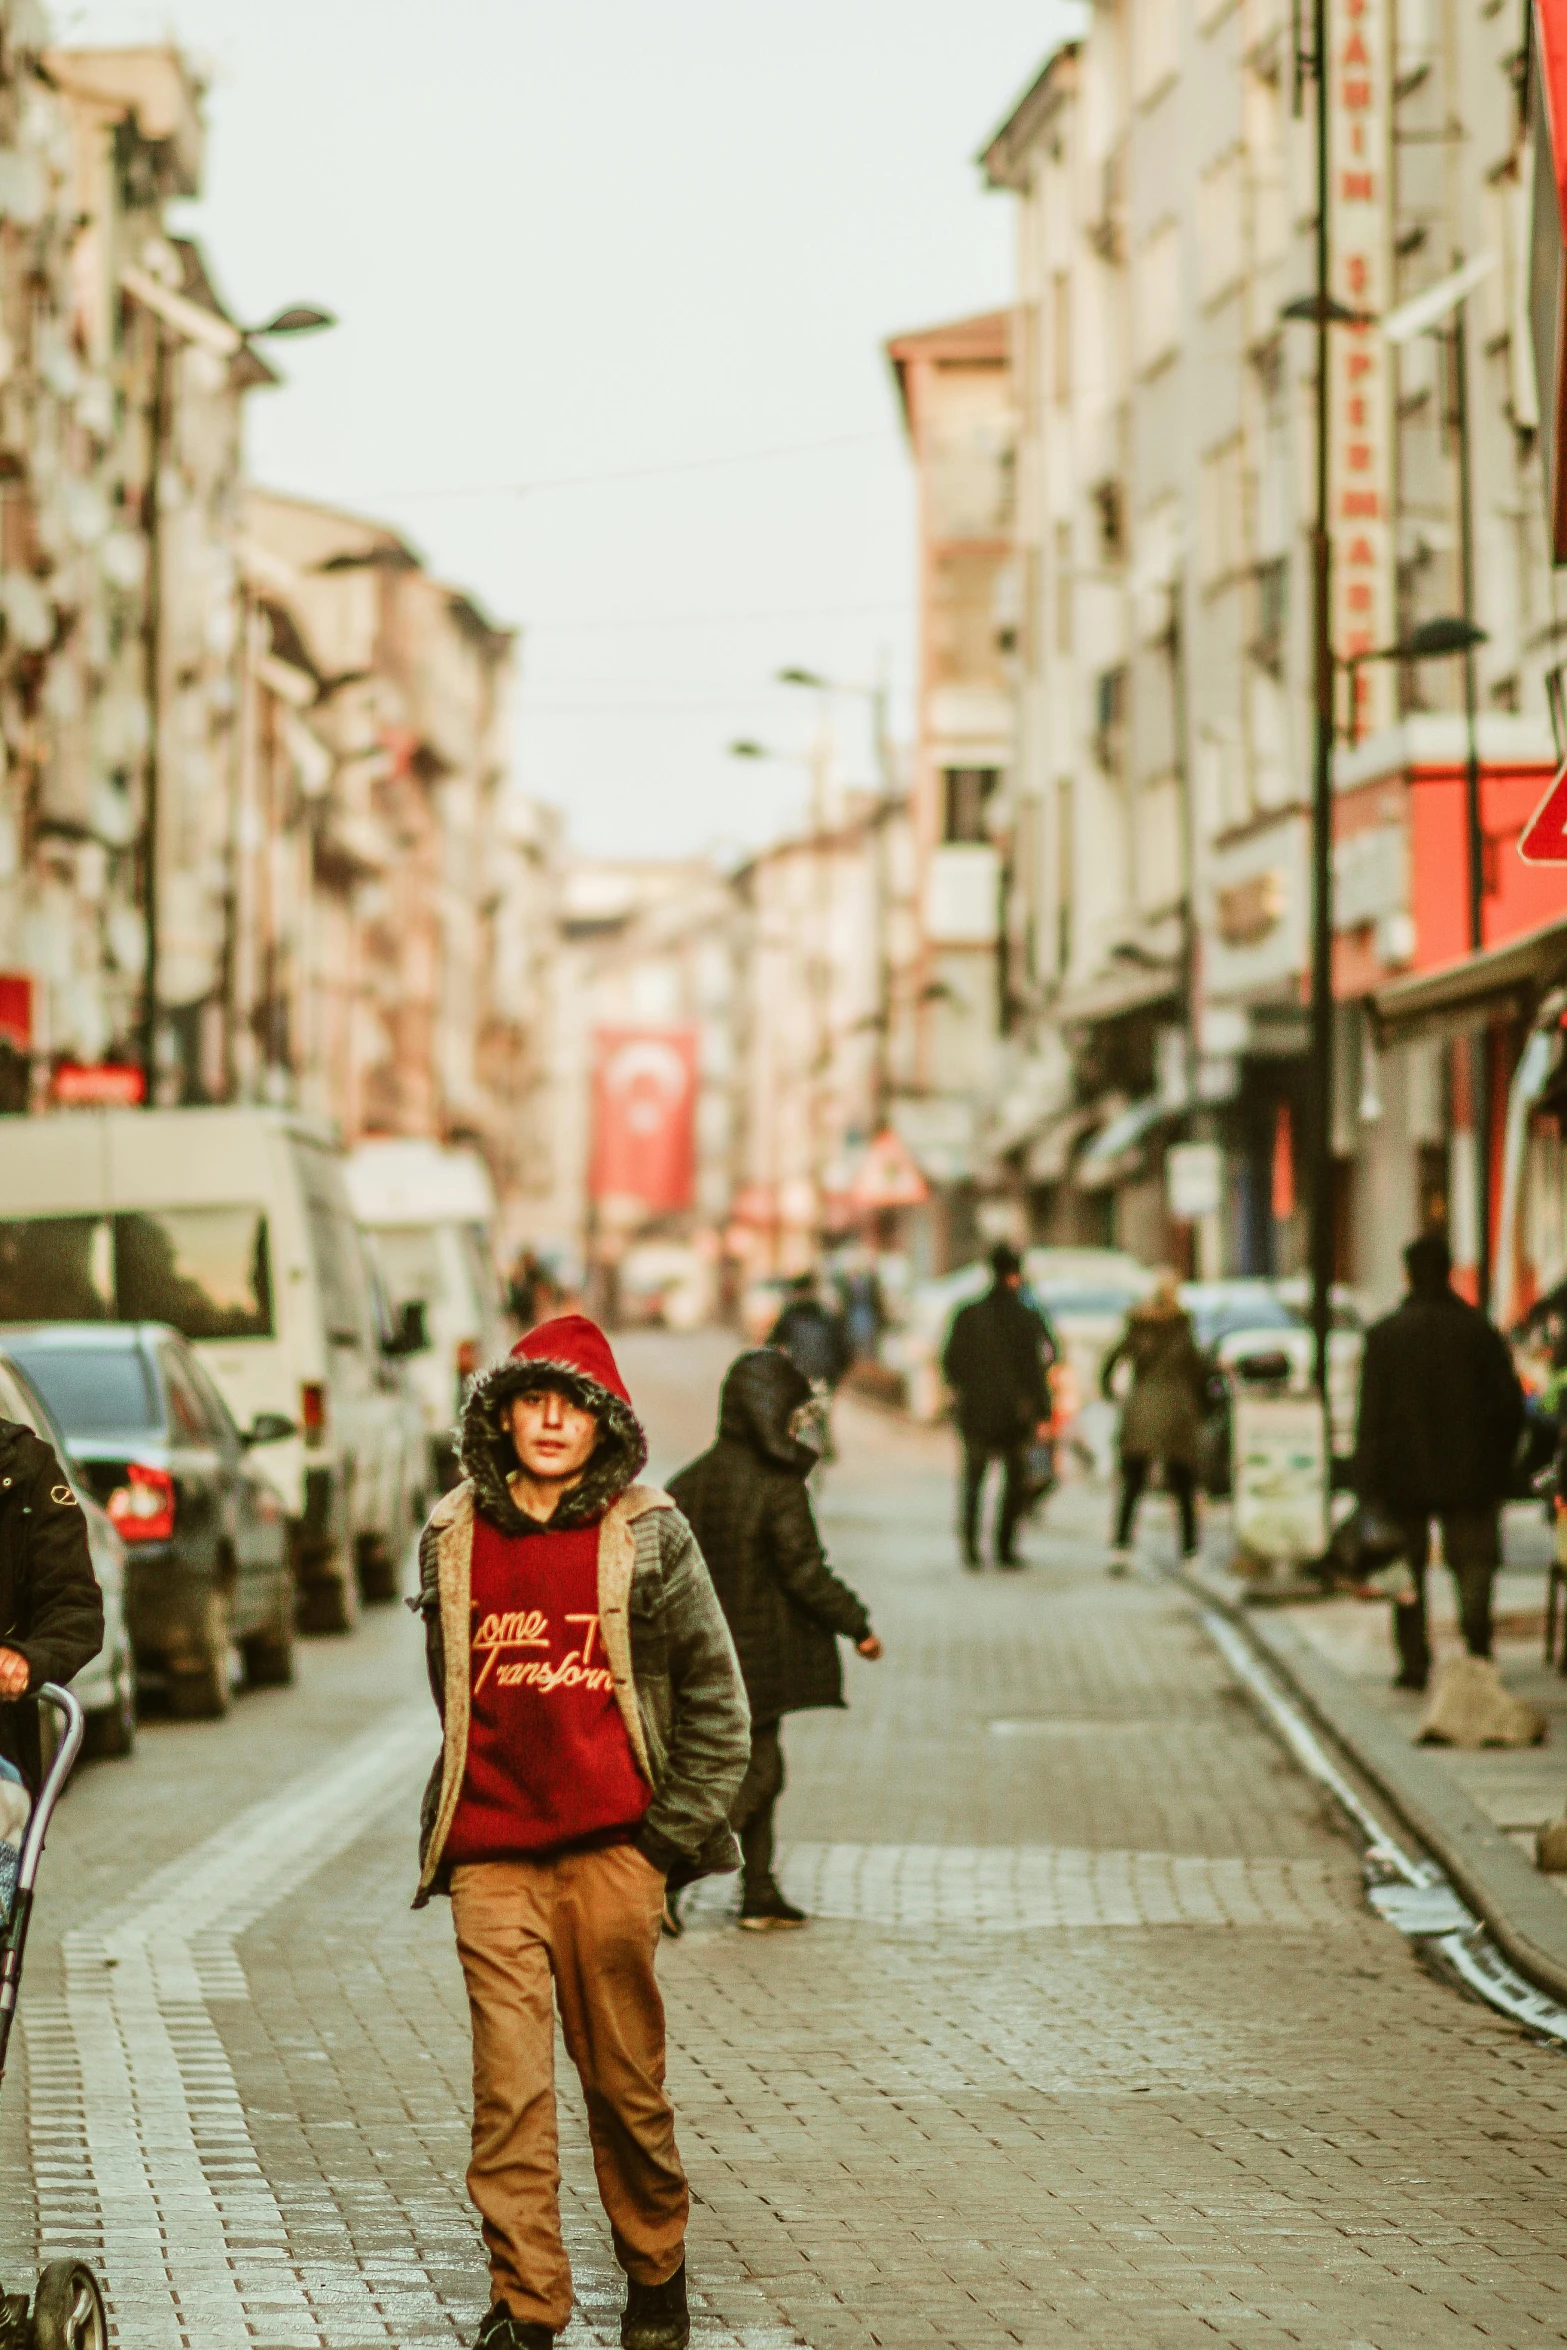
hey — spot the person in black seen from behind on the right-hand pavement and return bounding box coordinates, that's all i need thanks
[1356,1231,1522,1690]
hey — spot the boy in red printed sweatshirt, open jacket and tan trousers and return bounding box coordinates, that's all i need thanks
[411,1314,749,2350]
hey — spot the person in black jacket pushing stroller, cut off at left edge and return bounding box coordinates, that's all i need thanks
[0,1419,103,1793]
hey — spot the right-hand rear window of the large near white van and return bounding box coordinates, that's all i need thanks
[115,1208,273,1340]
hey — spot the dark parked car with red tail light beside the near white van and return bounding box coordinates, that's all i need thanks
[2,1323,294,1718]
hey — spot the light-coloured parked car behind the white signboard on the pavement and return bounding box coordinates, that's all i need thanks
[1182,1276,1365,1495]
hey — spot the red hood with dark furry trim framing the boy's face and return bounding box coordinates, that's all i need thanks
[458,1314,648,1535]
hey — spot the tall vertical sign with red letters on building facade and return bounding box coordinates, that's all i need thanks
[1327,0,1398,736]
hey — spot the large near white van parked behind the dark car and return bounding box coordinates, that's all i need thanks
[0,1109,428,1631]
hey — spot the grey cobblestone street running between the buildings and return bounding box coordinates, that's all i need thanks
[0,1337,1567,2350]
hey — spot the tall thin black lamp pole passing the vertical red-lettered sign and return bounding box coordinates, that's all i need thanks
[1309,0,1332,1398]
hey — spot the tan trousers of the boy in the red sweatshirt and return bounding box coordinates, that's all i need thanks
[451,1845,691,2334]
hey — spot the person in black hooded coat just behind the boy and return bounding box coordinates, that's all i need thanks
[667,1347,881,1934]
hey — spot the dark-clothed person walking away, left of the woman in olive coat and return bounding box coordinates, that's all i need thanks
[942,1241,1057,1570]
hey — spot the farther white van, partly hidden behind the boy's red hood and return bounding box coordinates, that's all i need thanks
[345,1137,510,1488]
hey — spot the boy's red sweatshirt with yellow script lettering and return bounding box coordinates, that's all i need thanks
[446,1511,653,1864]
